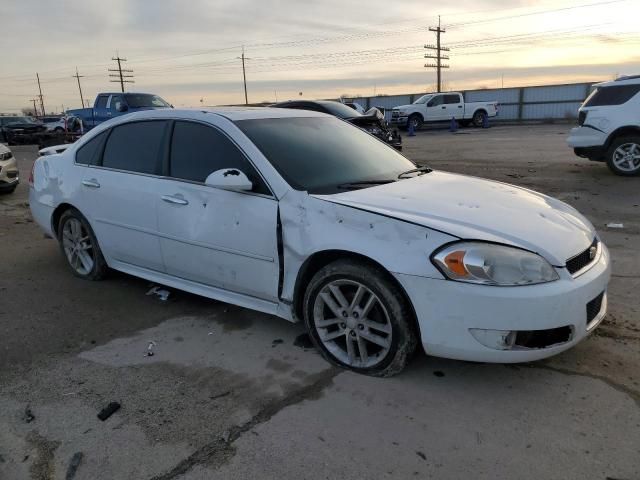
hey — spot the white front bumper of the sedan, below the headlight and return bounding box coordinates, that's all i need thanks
[394,245,611,363]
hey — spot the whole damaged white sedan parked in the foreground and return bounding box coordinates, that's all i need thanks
[30,108,610,376]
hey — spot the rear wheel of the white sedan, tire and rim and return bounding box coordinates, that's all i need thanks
[58,208,108,280]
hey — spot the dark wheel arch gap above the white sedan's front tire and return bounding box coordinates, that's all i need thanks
[292,249,420,338]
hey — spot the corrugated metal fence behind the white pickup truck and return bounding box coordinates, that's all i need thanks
[342,83,593,122]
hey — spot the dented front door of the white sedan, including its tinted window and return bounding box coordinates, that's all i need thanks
[156,120,279,301]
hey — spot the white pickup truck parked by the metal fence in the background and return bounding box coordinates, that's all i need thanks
[391,92,498,129]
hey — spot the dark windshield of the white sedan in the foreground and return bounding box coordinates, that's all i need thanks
[236,117,415,194]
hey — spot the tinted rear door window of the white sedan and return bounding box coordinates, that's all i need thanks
[102,121,167,174]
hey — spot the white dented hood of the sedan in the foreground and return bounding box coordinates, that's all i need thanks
[313,172,596,266]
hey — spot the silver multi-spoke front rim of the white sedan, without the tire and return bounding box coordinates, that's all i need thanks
[313,279,393,368]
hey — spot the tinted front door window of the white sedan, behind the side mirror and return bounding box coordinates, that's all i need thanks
[169,122,270,195]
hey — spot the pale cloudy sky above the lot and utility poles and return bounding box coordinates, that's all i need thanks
[0,0,640,112]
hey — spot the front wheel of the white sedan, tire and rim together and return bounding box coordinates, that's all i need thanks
[304,260,417,377]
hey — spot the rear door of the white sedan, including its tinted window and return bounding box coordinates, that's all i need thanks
[76,120,169,272]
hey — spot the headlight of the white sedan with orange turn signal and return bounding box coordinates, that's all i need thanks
[432,242,560,286]
